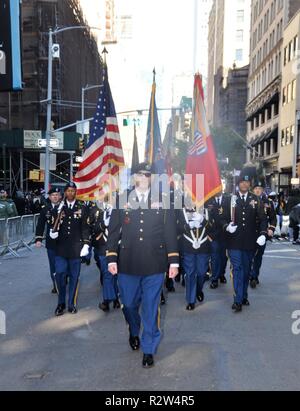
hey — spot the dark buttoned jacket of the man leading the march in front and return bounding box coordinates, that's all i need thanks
[106,194,179,276]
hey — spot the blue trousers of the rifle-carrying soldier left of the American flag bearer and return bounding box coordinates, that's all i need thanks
[55,256,81,308]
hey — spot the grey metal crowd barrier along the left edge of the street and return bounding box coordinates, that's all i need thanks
[0,214,39,257]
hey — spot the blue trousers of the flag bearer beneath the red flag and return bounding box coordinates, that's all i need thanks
[183,253,210,304]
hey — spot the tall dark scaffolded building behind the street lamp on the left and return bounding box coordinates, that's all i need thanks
[0,0,102,191]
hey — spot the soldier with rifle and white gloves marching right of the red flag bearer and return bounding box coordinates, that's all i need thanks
[222,171,268,312]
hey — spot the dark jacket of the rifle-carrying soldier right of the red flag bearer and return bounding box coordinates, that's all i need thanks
[222,192,268,251]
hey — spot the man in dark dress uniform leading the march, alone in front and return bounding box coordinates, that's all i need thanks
[107,163,179,368]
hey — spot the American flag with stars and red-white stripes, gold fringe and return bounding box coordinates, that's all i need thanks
[74,67,124,200]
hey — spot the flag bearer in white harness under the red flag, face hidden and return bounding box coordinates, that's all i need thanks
[177,207,214,311]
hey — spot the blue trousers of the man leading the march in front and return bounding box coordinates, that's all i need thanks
[118,273,165,354]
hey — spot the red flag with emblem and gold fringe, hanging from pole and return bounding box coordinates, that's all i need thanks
[185,74,222,207]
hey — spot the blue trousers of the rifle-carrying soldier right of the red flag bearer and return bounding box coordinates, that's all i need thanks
[228,250,254,304]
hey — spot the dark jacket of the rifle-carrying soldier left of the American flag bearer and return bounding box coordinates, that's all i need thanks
[53,201,90,259]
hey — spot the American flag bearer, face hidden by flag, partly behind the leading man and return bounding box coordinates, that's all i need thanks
[88,201,121,312]
